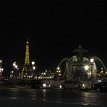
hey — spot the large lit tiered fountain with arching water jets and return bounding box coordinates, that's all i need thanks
[56,45,107,87]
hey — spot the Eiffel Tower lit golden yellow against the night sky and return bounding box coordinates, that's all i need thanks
[20,40,32,79]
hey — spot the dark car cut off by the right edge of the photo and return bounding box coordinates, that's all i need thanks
[94,81,107,92]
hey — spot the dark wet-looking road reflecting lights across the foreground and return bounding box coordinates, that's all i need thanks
[0,87,107,107]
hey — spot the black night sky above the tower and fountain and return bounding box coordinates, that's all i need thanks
[0,0,107,72]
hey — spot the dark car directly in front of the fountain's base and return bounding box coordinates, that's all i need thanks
[62,81,88,90]
